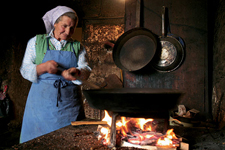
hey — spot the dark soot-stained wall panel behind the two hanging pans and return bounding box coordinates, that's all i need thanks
[124,0,213,119]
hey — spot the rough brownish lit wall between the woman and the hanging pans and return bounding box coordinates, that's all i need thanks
[84,24,124,85]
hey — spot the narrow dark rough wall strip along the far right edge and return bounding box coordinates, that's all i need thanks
[212,0,225,128]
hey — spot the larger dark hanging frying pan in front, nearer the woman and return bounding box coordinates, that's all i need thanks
[113,0,157,71]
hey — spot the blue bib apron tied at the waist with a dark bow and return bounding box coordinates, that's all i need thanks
[20,38,85,143]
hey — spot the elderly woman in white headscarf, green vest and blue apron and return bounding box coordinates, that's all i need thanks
[20,6,91,143]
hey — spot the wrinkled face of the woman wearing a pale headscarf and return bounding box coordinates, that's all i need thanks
[54,16,75,41]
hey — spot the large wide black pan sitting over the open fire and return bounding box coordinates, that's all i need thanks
[83,88,183,112]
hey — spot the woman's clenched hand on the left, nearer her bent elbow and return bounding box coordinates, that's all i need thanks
[36,60,58,75]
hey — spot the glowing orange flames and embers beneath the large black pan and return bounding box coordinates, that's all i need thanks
[98,110,179,147]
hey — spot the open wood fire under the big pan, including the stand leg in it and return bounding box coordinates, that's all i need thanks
[98,111,181,149]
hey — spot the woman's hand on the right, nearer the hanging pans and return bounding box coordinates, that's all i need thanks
[62,67,80,81]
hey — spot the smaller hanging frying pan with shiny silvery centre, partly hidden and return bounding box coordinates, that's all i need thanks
[151,6,184,72]
